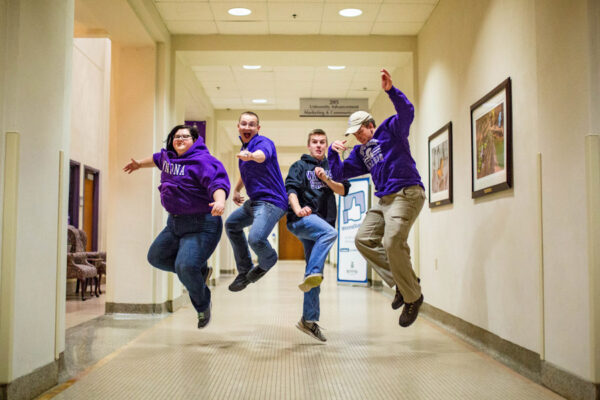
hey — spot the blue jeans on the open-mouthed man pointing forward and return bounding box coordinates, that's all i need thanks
[225,200,285,274]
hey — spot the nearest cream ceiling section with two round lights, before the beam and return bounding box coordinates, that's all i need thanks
[154,0,439,35]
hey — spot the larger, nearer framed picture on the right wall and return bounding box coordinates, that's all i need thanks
[471,78,512,198]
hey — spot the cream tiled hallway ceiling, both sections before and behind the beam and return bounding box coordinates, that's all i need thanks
[154,0,438,110]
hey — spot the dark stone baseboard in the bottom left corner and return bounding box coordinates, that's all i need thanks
[0,353,64,400]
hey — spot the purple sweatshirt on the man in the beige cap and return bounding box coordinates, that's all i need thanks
[327,86,425,197]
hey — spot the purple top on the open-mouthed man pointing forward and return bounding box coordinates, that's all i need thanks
[238,134,288,210]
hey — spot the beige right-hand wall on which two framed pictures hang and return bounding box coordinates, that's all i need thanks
[413,0,590,379]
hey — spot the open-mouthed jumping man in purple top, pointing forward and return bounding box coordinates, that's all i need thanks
[225,111,287,292]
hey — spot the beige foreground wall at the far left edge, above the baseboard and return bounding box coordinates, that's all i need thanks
[0,0,73,382]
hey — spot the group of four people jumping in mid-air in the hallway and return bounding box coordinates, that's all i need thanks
[123,69,425,342]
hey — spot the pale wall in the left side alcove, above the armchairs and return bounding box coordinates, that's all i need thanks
[70,39,111,250]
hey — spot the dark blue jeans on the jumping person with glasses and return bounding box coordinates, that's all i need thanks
[148,214,223,312]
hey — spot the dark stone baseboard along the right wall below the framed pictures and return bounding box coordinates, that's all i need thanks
[422,304,600,400]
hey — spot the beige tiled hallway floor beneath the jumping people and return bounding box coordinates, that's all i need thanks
[45,262,561,400]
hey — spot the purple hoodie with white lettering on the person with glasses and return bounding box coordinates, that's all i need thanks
[152,137,229,215]
